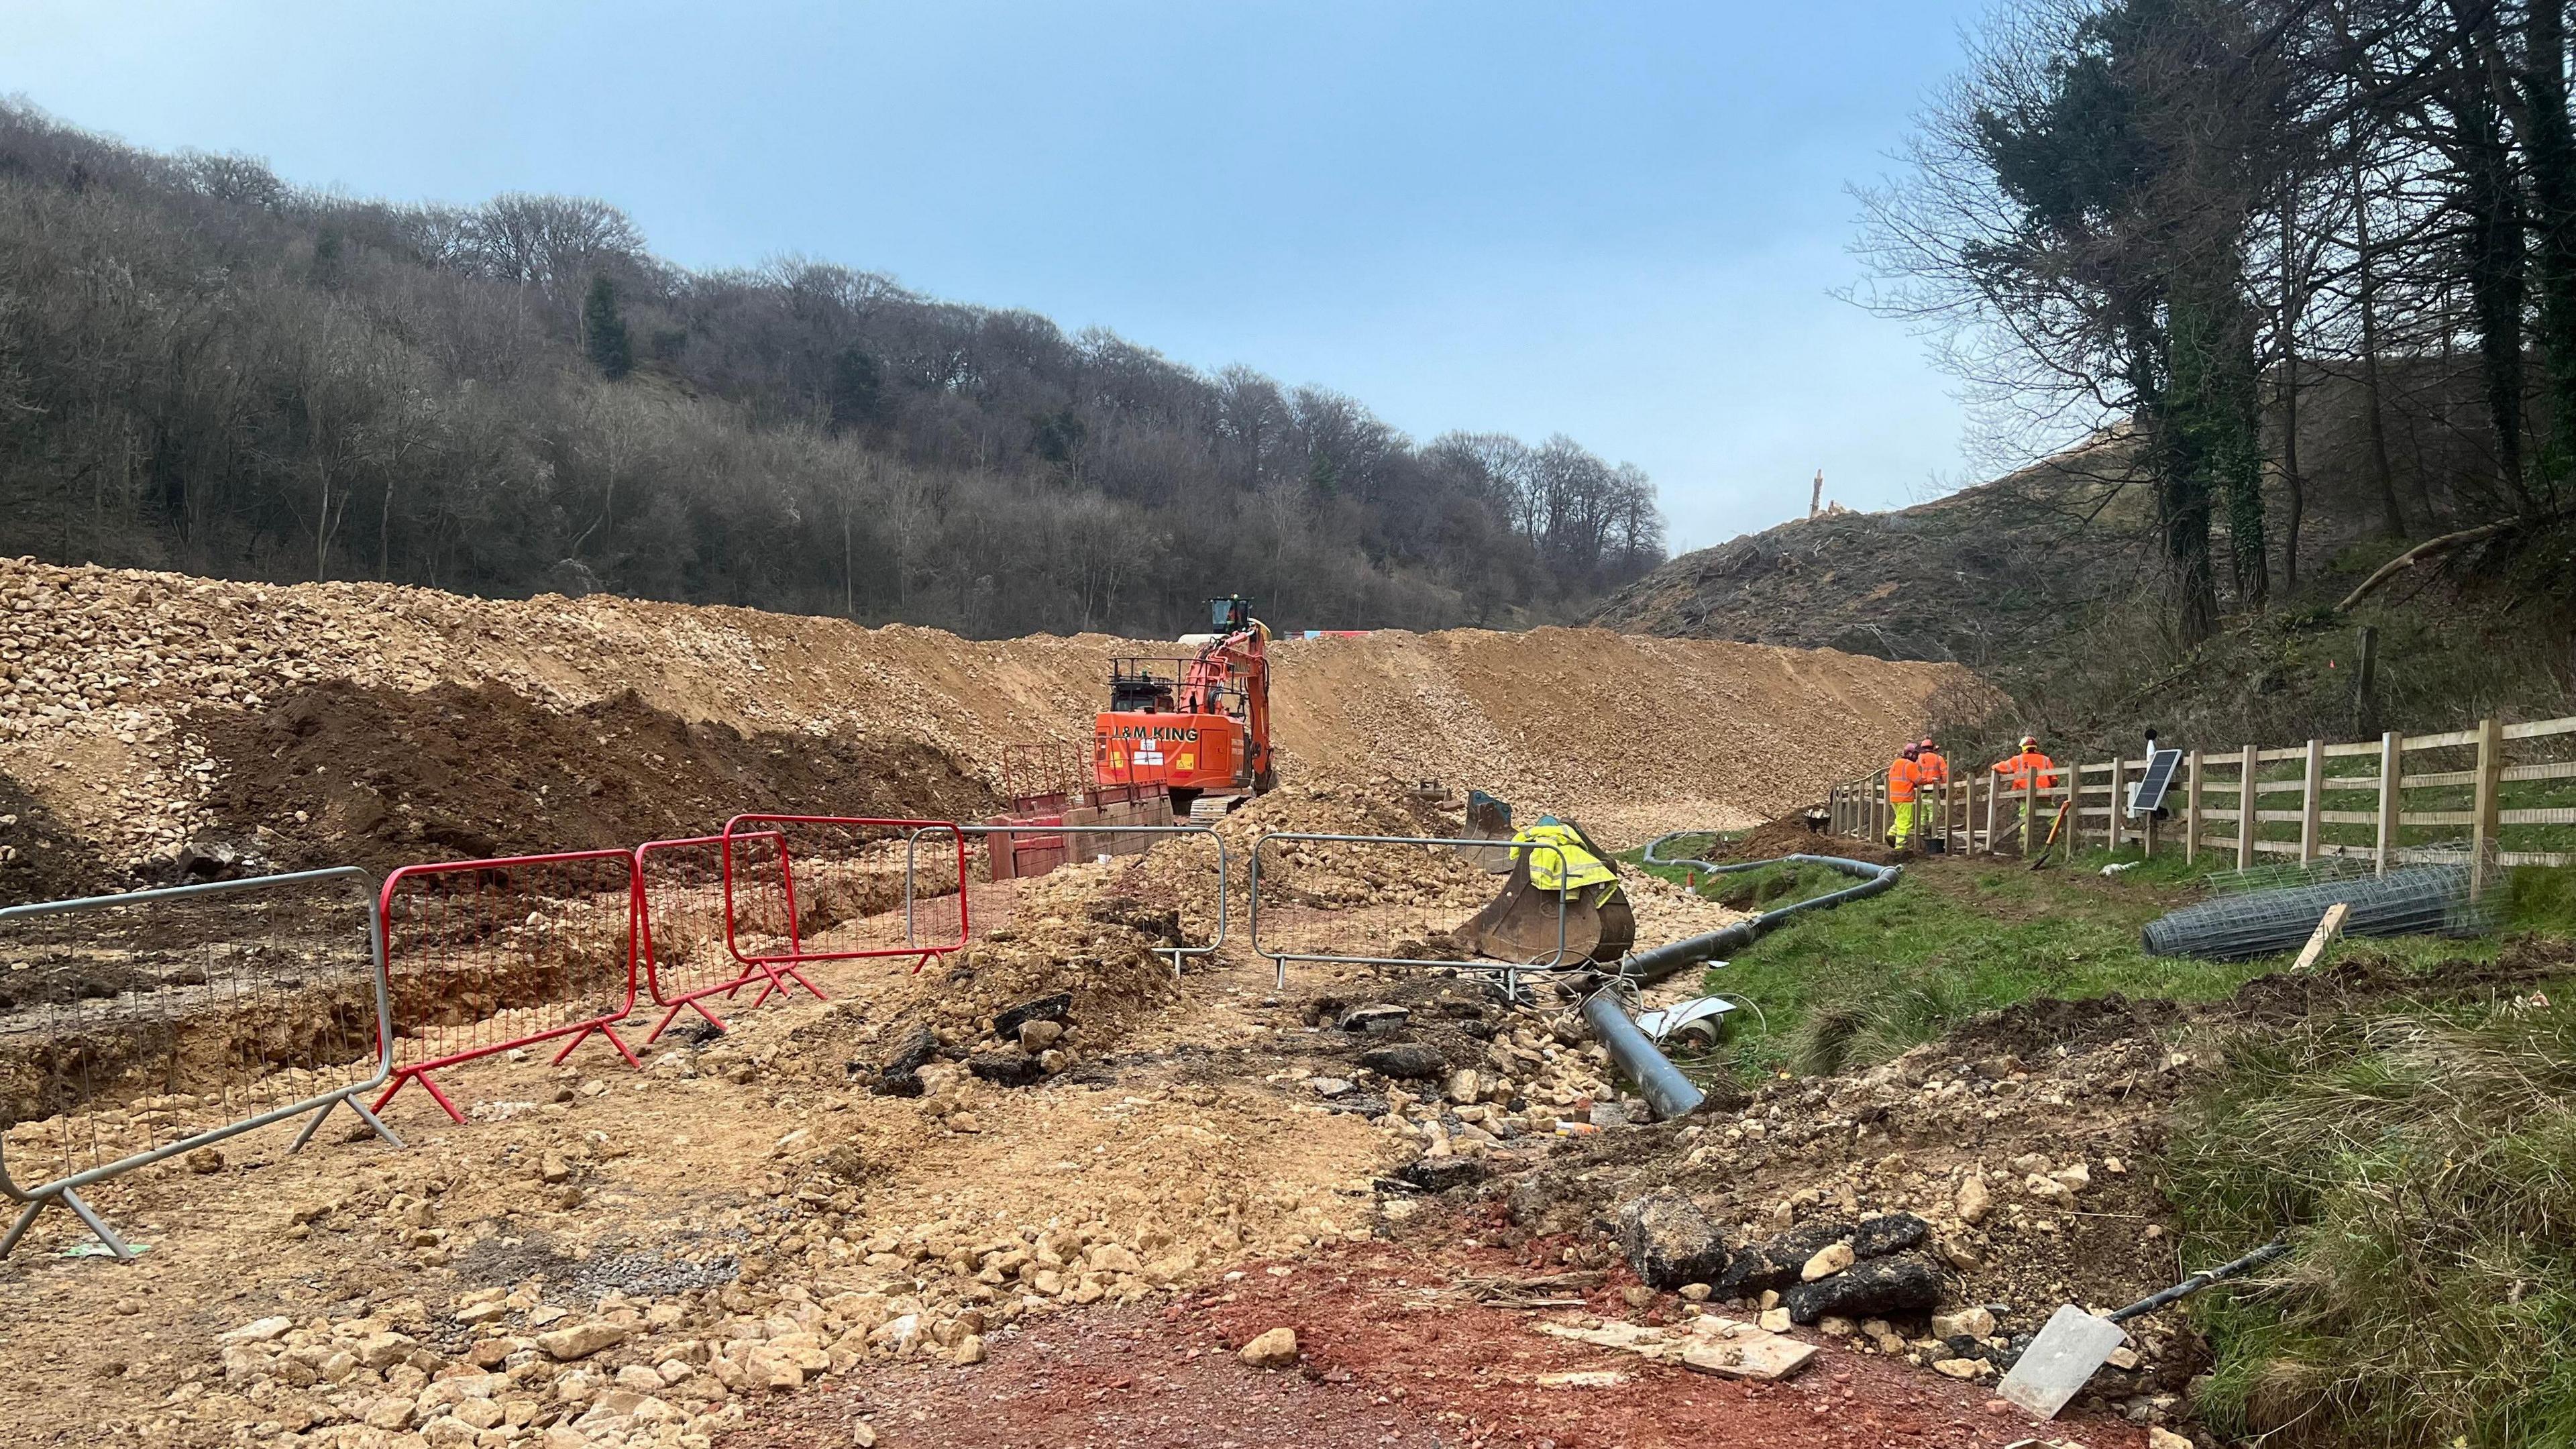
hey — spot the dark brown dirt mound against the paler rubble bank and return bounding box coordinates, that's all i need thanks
[188,681,994,869]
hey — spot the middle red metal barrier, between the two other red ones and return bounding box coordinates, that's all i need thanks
[636,830,793,1044]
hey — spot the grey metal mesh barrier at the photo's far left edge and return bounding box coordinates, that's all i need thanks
[0,866,402,1258]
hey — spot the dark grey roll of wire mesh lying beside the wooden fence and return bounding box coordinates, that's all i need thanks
[2146,866,2496,962]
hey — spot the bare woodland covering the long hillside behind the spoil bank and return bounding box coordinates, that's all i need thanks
[0,106,1664,637]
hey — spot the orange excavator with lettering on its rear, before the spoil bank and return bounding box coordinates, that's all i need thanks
[1092,596,1275,820]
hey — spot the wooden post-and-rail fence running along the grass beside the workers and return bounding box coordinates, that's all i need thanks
[1827,719,2576,892]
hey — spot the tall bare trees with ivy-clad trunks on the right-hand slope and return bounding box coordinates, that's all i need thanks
[1860,0,2576,645]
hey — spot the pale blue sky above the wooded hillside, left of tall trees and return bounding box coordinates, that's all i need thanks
[0,0,1976,547]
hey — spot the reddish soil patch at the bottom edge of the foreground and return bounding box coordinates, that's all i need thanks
[724,1227,2146,1449]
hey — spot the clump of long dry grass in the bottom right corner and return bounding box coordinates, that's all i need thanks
[2171,993,2576,1449]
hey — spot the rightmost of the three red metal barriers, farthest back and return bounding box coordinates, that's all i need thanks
[724,815,969,969]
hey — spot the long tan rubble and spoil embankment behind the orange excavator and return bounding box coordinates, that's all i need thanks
[0,562,1963,881]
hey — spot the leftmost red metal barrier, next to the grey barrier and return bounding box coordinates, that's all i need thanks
[374,851,641,1122]
